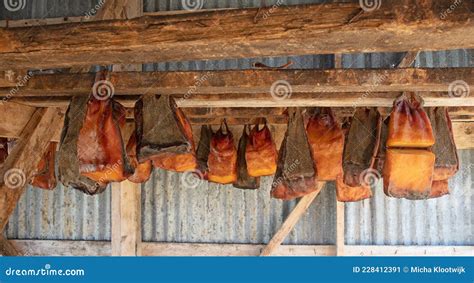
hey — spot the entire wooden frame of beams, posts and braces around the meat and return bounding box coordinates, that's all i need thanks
[0,0,474,256]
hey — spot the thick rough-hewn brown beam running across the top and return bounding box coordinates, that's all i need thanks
[0,0,474,70]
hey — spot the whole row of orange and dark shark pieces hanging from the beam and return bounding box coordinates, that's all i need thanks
[14,72,459,201]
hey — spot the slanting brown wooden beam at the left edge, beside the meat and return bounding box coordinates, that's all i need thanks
[0,108,62,231]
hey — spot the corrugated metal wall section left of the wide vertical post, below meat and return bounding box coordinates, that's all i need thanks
[7,185,111,240]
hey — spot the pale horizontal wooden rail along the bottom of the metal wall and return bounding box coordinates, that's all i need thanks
[10,240,474,256]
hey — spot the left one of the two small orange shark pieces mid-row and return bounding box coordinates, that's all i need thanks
[207,120,237,184]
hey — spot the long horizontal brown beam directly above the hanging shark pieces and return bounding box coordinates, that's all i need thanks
[0,68,474,98]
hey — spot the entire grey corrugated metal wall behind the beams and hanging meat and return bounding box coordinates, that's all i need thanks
[0,0,474,245]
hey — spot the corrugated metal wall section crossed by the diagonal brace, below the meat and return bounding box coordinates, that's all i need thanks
[142,170,336,244]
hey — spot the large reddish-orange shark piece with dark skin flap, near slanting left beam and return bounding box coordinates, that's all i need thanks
[58,71,133,194]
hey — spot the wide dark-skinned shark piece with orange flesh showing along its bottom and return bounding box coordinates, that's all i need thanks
[135,94,197,172]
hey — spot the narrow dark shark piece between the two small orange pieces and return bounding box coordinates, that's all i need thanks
[234,125,260,190]
